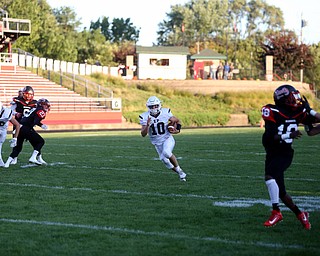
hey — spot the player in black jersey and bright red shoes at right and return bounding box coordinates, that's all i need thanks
[262,84,320,229]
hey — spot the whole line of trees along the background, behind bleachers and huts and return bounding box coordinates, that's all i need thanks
[0,0,320,92]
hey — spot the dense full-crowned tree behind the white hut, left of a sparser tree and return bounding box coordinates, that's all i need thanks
[157,0,228,45]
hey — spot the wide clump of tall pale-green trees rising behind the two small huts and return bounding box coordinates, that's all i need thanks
[157,0,284,46]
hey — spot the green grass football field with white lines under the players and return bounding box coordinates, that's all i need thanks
[0,127,320,256]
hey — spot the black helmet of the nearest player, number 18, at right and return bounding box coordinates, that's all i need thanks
[273,84,302,110]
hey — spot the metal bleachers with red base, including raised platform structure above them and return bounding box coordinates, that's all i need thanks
[0,8,123,130]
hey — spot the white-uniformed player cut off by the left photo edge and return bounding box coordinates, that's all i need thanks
[0,102,20,167]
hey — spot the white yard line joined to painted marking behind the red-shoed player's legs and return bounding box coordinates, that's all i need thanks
[0,183,320,212]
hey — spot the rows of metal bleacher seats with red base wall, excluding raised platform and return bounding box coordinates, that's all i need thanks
[0,63,122,129]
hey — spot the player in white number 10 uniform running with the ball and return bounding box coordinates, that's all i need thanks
[139,96,187,181]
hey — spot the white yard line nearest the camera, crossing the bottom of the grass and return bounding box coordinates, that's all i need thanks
[0,218,304,249]
